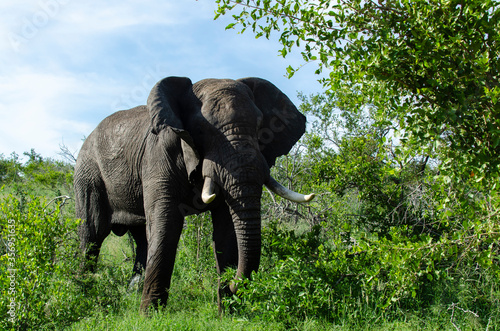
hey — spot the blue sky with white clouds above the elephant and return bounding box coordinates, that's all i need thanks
[0,0,322,159]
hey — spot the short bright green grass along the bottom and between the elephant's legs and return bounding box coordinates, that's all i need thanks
[66,235,480,331]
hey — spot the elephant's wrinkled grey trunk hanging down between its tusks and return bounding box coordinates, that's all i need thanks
[202,137,269,293]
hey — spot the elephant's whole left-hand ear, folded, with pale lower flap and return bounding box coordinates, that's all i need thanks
[147,77,200,179]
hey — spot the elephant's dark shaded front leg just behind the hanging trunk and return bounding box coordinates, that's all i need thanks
[212,203,238,313]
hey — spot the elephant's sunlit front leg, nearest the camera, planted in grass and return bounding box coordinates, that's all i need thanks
[141,200,184,311]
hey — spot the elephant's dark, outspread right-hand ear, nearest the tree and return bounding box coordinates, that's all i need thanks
[238,77,306,167]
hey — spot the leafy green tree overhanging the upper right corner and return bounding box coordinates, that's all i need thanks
[216,0,500,187]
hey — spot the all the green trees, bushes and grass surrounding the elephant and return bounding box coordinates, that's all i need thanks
[0,0,500,330]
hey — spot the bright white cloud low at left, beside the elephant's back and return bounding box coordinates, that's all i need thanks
[0,70,114,156]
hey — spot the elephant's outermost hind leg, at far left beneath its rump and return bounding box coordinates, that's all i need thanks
[75,174,111,272]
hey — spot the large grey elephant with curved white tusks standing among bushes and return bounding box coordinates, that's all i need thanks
[74,77,314,312]
